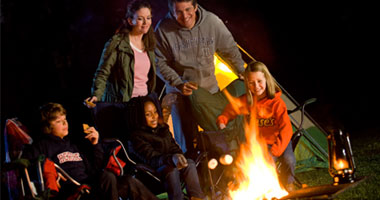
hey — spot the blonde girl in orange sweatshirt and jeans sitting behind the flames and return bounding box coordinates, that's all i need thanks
[217,61,296,190]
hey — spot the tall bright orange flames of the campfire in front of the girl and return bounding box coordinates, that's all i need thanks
[224,91,288,200]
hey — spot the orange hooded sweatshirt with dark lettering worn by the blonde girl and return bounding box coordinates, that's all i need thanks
[217,92,293,157]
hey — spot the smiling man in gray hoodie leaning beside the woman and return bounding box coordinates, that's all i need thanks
[155,0,244,155]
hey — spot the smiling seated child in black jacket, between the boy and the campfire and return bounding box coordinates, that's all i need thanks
[131,97,208,200]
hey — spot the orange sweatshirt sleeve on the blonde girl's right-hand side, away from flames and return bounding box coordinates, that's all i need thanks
[271,100,293,157]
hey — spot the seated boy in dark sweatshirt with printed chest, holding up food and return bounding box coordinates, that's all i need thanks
[23,103,155,200]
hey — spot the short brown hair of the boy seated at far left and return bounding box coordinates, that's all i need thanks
[40,103,66,134]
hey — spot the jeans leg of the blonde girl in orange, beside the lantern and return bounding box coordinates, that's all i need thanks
[269,141,296,186]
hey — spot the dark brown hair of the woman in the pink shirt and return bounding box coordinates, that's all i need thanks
[116,0,156,51]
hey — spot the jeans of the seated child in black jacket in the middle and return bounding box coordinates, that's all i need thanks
[157,159,204,200]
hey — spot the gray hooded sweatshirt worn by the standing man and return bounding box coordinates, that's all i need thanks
[155,5,244,94]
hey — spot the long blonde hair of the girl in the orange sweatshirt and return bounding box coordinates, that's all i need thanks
[244,61,281,105]
